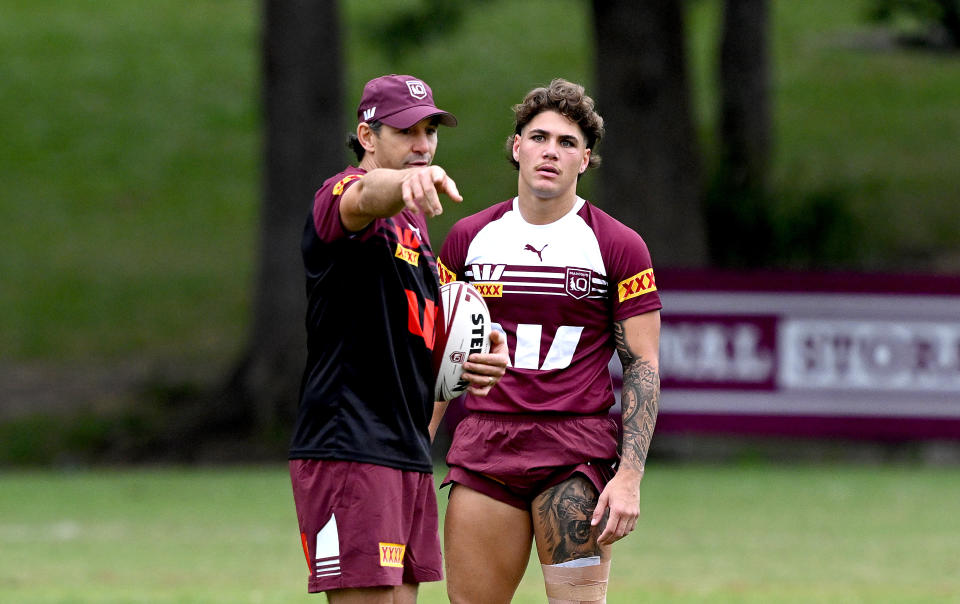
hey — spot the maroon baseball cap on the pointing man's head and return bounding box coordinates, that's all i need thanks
[357,74,457,130]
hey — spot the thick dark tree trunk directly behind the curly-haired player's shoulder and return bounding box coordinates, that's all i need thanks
[593,0,707,267]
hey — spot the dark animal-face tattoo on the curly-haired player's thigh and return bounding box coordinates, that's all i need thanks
[533,477,606,564]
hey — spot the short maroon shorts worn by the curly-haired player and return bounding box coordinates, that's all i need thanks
[442,413,617,510]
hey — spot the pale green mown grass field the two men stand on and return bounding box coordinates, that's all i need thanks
[0,464,960,604]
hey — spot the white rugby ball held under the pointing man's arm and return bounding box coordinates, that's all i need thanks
[433,281,490,401]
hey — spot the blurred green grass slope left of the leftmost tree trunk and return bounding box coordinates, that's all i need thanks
[0,0,259,360]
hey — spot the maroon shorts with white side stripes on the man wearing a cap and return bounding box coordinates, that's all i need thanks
[290,459,443,593]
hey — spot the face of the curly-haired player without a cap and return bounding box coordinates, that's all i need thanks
[513,111,590,199]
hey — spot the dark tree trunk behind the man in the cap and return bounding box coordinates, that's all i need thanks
[227,0,346,434]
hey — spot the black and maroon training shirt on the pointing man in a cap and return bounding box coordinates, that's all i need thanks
[290,167,439,472]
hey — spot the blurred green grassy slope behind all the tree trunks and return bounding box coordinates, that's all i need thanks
[0,0,960,365]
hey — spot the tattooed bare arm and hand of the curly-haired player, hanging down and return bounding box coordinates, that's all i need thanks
[591,311,660,545]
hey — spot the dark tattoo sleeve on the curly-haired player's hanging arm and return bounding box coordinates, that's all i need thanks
[613,321,660,470]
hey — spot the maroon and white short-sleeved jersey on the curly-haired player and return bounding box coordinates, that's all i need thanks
[439,197,661,415]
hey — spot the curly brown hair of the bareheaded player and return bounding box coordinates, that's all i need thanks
[507,78,603,169]
